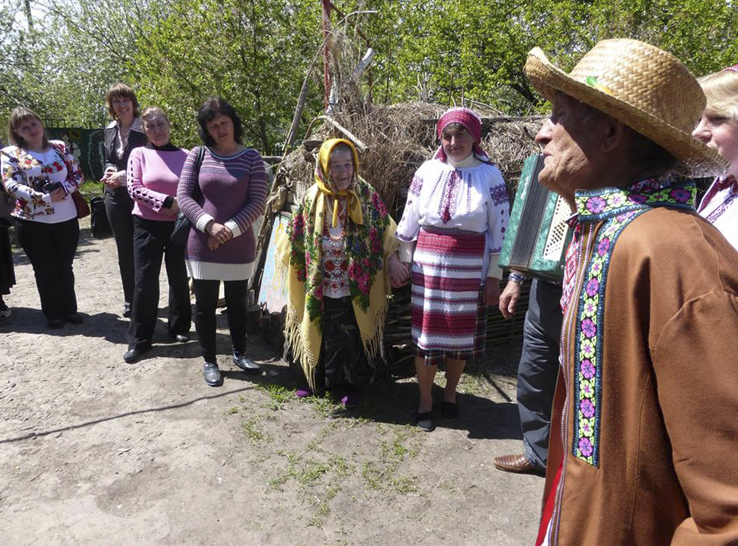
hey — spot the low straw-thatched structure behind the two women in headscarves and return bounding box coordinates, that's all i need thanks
[250,103,542,375]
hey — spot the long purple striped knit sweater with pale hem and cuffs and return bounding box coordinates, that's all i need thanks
[177,148,267,281]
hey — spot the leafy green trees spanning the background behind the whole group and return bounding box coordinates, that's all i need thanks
[0,0,738,142]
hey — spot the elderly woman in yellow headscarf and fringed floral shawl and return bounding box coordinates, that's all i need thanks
[278,139,409,408]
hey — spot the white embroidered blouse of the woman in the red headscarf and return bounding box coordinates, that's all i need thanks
[396,154,510,279]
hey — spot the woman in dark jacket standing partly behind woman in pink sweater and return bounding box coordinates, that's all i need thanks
[102,83,146,317]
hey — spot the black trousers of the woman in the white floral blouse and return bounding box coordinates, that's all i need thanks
[15,218,79,320]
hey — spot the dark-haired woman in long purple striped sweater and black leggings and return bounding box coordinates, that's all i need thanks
[177,98,267,387]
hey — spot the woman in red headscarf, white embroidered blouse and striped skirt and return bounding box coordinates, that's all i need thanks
[397,108,509,431]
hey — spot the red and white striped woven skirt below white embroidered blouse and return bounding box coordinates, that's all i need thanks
[412,227,487,365]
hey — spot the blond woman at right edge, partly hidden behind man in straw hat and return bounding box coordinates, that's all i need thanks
[692,64,738,249]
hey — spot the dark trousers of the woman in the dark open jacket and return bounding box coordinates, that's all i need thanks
[104,186,136,303]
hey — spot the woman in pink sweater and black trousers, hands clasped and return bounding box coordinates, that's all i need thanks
[123,107,192,363]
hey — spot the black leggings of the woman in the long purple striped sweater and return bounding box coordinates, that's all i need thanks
[193,279,248,363]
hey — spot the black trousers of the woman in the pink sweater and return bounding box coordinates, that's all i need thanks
[128,216,192,349]
